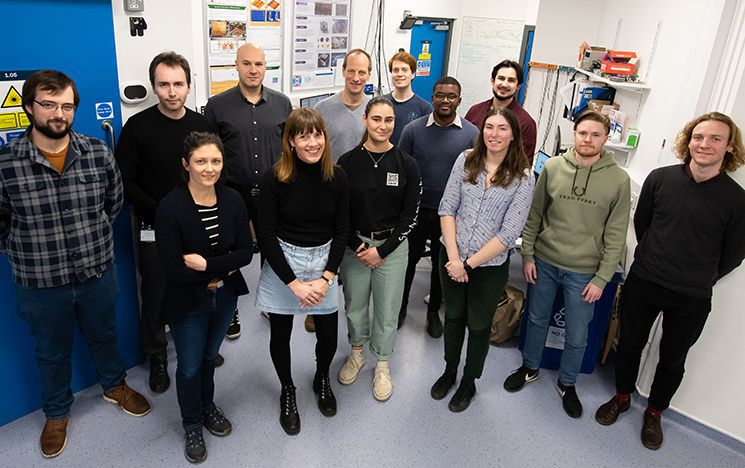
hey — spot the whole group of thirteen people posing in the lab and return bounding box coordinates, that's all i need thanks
[0,44,745,463]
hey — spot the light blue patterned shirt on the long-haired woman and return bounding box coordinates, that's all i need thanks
[438,150,534,266]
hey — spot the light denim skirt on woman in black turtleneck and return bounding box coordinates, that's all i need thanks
[256,239,339,315]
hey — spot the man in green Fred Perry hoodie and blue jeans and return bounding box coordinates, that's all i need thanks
[504,112,631,418]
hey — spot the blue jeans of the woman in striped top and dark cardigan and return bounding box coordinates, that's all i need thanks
[171,286,238,431]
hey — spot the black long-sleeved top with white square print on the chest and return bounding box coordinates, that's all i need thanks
[339,145,422,258]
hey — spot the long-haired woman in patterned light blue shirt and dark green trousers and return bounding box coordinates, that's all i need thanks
[431,109,533,413]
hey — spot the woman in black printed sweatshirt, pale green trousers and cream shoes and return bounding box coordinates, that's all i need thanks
[338,97,422,401]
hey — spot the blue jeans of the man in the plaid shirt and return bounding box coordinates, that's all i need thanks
[15,266,126,419]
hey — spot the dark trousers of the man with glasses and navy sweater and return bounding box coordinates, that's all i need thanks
[401,208,442,311]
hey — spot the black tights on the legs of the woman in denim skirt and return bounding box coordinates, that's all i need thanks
[269,312,339,386]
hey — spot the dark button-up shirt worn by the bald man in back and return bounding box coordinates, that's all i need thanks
[204,86,292,192]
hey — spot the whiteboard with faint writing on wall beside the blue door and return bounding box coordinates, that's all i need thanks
[456,16,525,115]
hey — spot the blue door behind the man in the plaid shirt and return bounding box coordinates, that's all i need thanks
[0,0,144,424]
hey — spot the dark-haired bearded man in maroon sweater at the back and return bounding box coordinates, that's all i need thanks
[466,60,536,166]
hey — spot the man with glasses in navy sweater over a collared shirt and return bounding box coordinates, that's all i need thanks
[398,76,479,338]
